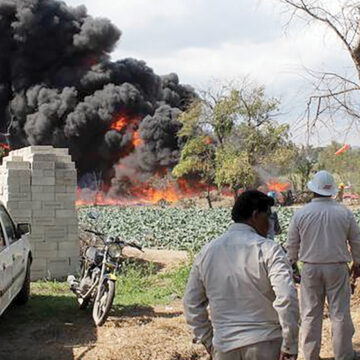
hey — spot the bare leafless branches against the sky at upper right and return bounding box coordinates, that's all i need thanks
[279,0,360,132]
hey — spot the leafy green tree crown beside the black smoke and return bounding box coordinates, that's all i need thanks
[173,80,292,205]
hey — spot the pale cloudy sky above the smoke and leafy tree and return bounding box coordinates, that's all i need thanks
[65,0,360,145]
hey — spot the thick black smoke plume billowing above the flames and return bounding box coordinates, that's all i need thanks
[0,0,195,186]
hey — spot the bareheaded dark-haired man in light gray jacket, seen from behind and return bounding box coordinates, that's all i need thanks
[184,190,298,360]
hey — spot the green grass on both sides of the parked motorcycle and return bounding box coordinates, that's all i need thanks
[0,262,191,329]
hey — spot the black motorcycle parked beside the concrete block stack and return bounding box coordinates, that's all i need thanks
[67,213,142,326]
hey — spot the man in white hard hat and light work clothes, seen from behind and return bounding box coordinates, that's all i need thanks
[285,171,360,360]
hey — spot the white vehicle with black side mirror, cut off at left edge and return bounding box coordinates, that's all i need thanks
[0,202,32,315]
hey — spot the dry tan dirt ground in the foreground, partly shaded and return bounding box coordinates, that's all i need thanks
[0,250,360,360]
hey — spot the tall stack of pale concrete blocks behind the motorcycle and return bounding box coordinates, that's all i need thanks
[0,146,80,279]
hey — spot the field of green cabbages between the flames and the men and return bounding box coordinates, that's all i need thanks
[79,206,360,251]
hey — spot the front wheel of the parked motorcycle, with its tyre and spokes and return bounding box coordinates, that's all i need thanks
[92,279,115,326]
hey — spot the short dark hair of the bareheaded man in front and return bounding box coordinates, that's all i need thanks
[231,190,274,222]
